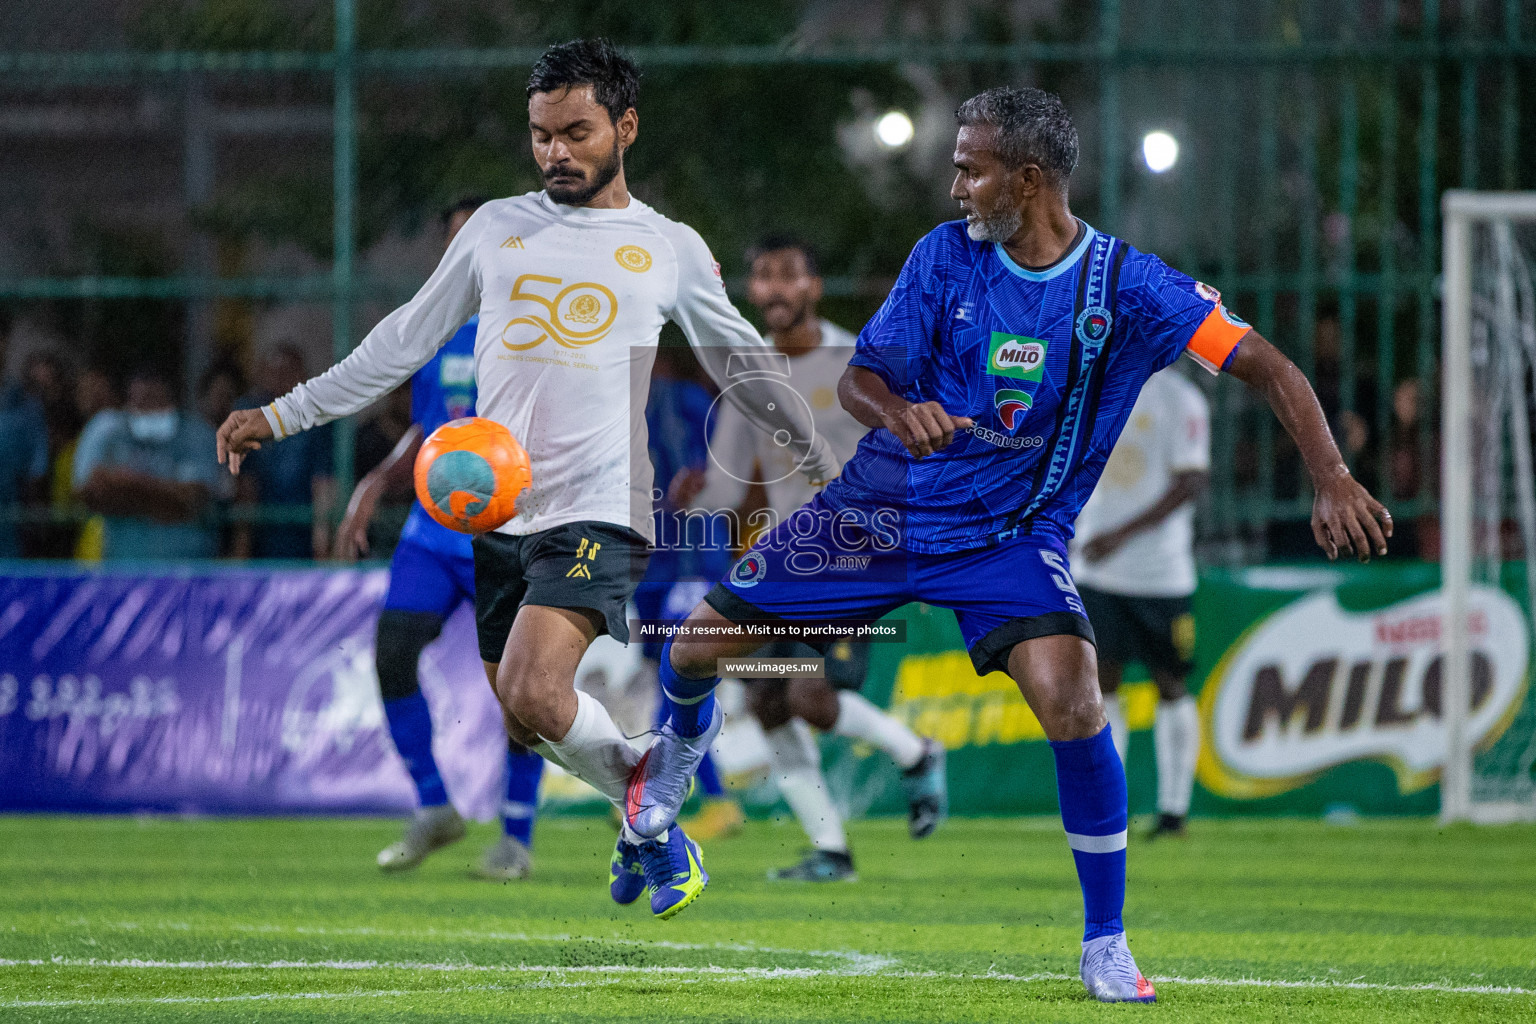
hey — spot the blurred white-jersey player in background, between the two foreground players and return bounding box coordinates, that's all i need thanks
[679,235,948,881]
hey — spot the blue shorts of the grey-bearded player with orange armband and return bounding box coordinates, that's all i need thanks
[705,496,1094,674]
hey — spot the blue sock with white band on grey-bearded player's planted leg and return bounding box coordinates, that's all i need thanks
[1051,726,1129,943]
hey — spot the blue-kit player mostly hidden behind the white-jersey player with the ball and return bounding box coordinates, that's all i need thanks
[338,200,544,881]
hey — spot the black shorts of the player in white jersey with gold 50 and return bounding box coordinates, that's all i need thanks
[473,522,650,662]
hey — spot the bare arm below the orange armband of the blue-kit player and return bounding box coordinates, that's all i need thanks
[1227,330,1392,562]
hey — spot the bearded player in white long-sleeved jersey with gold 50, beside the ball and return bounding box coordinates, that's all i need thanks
[218,40,837,918]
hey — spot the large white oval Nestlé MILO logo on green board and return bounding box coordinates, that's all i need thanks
[1198,586,1528,800]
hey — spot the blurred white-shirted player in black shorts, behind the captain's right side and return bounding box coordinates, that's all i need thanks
[1071,368,1210,835]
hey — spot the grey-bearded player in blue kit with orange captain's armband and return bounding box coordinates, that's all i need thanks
[627,89,1392,1003]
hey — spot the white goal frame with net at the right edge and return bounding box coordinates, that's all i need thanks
[1441,192,1536,823]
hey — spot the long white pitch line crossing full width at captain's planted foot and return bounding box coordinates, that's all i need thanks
[0,956,1536,1006]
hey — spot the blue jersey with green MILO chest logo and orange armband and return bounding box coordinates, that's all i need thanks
[825,221,1249,553]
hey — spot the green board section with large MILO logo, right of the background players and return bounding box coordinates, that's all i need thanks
[1195,565,1533,812]
